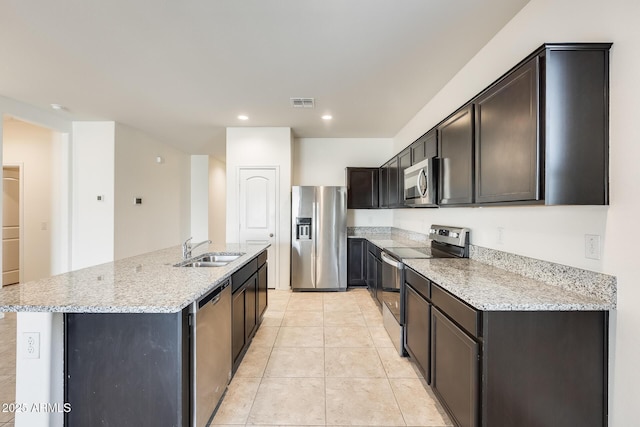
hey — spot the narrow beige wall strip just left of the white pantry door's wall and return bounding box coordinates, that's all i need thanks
[209,156,227,243]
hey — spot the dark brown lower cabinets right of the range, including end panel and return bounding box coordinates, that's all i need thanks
[416,269,609,427]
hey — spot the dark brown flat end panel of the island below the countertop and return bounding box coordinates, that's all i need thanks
[64,308,191,427]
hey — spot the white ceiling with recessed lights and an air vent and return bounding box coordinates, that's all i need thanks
[0,0,528,157]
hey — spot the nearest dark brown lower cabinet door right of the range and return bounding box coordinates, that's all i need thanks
[431,307,480,427]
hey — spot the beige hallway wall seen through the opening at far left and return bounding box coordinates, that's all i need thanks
[3,119,53,282]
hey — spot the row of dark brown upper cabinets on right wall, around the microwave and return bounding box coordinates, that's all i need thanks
[350,43,612,208]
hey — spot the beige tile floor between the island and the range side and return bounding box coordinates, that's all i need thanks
[212,289,452,426]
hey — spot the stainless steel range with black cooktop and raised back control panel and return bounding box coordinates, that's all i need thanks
[382,225,469,355]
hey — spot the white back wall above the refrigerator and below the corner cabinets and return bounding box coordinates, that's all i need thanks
[292,138,395,227]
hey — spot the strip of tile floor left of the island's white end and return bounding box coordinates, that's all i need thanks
[0,313,16,427]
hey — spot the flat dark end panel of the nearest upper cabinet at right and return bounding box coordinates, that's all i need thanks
[540,43,611,205]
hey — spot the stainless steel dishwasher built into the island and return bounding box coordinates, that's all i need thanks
[191,281,231,427]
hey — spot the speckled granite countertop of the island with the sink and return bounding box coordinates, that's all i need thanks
[0,244,269,313]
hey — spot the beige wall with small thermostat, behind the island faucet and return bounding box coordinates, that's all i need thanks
[112,124,191,259]
